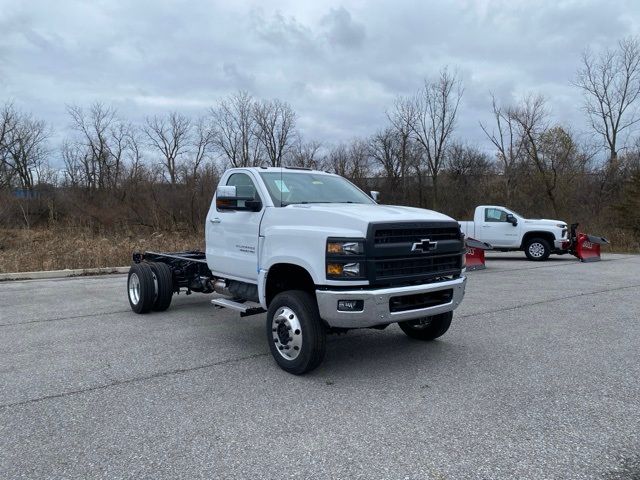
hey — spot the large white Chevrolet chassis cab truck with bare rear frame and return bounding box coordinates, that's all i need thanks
[127,167,466,374]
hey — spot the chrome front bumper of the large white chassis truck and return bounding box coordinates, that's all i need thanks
[316,277,467,328]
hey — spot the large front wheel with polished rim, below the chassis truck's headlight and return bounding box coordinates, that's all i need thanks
[266,290,326,375]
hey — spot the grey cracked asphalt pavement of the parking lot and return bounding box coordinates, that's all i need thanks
[0,253,640,480]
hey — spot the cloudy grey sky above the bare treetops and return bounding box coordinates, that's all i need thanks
[0,0,640,158]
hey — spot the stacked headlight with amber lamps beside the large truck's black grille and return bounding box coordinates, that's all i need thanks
[326,238,366,280]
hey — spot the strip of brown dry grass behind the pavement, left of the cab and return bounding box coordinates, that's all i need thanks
[0,228,204,273]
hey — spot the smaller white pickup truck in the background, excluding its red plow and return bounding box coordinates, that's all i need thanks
[459,205,570,261]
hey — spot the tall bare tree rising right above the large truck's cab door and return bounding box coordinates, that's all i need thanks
[211,91,262,167]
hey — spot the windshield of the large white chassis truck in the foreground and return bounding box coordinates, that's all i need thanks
[260,171,374,207]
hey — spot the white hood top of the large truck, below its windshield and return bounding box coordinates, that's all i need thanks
[285,203,455,224]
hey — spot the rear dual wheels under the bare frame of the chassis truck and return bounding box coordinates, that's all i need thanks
[127,262,173,313]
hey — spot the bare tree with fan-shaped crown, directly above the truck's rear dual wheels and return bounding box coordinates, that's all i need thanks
[143,112,191,185]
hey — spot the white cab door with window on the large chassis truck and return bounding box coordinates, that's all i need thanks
[205,172,264,282]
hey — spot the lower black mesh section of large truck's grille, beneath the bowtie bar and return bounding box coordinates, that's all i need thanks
[375,254,460,280]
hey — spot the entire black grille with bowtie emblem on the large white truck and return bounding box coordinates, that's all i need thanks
[366,221,464,286]
